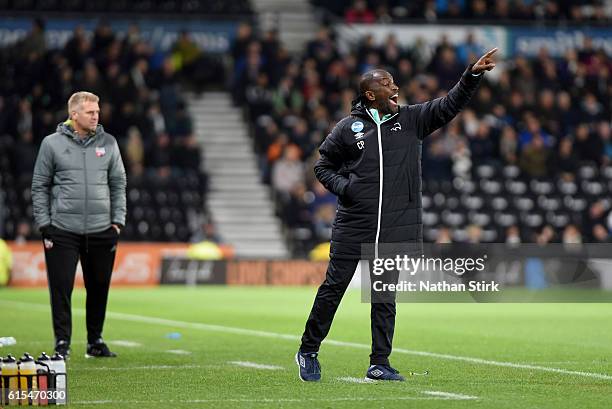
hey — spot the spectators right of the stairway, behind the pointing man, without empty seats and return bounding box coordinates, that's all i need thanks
[233,21,612,252]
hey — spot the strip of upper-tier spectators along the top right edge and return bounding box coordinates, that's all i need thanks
[311,0,612,24]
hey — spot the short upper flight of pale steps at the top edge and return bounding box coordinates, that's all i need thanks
[252,0,319,54]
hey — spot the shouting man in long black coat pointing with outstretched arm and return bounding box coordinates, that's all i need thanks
[295,48,497,381]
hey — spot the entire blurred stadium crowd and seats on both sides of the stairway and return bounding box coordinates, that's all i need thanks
[0,0,612,256]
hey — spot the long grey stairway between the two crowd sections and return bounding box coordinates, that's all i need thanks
[186,92,289,258]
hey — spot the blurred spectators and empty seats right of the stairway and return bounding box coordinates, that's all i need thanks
[234,22,612,253]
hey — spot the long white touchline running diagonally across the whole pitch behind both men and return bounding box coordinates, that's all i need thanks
[0,300,612,381]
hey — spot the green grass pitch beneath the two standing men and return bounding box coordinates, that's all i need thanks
[0,287,612,409]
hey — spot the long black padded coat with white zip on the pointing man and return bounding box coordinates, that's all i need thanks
[314,67,482,259]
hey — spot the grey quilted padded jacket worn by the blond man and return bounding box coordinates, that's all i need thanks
[32,121,127,234]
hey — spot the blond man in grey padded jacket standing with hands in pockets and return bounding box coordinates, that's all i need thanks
[32,92,126,357]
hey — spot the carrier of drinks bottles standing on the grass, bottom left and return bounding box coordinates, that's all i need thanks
[0,352,67,407]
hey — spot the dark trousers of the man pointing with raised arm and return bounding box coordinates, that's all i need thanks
[300,258,395,365]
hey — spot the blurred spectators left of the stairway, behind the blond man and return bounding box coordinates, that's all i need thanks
[0,19,205,240]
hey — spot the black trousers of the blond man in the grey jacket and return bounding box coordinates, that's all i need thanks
[43,227,118,344]
